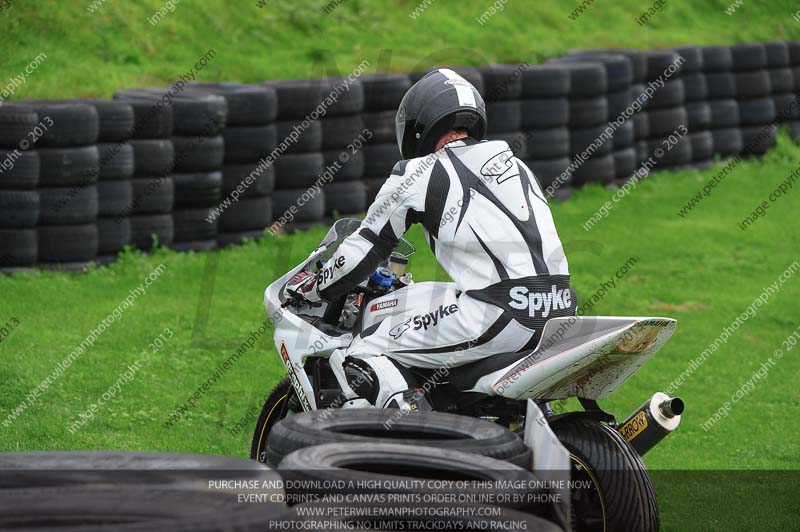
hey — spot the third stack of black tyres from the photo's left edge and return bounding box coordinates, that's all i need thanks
[81,100,134,264]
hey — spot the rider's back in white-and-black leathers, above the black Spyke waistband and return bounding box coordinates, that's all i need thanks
[382,139,569,291]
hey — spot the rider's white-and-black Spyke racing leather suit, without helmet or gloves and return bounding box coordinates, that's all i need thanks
[317,139,577,407]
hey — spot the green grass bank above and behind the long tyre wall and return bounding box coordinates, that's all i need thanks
[0,0,800,99]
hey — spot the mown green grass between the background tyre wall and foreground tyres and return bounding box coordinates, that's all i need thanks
[0,138,800,530]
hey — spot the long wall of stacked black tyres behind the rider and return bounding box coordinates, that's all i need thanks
[0,41,800,273]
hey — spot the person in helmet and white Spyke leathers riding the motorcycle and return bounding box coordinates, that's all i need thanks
[285,68,577,409]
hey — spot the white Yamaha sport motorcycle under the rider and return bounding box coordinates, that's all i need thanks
[250,218,683,531]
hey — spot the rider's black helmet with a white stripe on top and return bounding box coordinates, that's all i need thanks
[395,68,486,159]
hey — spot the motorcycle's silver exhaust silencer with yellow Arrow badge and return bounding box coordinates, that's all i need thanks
[619,392,685,456]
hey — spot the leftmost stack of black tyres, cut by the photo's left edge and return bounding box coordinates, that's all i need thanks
[0,103,39,273]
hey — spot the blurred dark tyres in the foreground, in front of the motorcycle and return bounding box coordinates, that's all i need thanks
[0,414,564,532]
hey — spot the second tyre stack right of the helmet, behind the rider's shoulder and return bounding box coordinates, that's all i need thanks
[512,65,572,198]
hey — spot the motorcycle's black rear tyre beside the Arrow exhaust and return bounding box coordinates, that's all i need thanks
[552,417,659,532]
